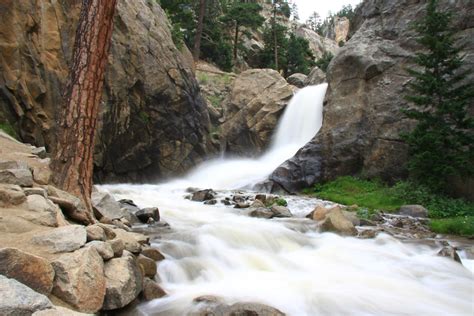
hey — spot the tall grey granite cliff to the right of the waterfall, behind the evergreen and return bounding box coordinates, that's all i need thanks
[270,0,474,195]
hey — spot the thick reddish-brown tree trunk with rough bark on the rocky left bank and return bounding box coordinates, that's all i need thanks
[51,0,116,218]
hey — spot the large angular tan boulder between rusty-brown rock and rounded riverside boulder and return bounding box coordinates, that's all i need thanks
[52,247,106,313]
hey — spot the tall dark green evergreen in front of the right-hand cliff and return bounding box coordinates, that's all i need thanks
[402,0,474,191]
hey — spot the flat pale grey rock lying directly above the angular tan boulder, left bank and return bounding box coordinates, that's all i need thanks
[32,225,87,253]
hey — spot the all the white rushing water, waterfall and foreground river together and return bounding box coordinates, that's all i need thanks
[101,85,474,316]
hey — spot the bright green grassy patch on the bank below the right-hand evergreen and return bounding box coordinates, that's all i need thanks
[303,176,474,236]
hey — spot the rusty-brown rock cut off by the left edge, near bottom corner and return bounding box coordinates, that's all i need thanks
[0,248,54,295]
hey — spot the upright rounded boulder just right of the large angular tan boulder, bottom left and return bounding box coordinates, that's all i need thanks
[103,253,143,310]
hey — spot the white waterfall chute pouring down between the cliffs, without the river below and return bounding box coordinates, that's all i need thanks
[175,83,327,189]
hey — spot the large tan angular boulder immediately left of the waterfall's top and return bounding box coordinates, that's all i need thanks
[220,69,296,154]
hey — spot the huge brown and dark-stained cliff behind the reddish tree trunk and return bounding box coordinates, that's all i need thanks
[0,0,209,181]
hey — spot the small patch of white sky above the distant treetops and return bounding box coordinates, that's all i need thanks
[288,0,361,22]
